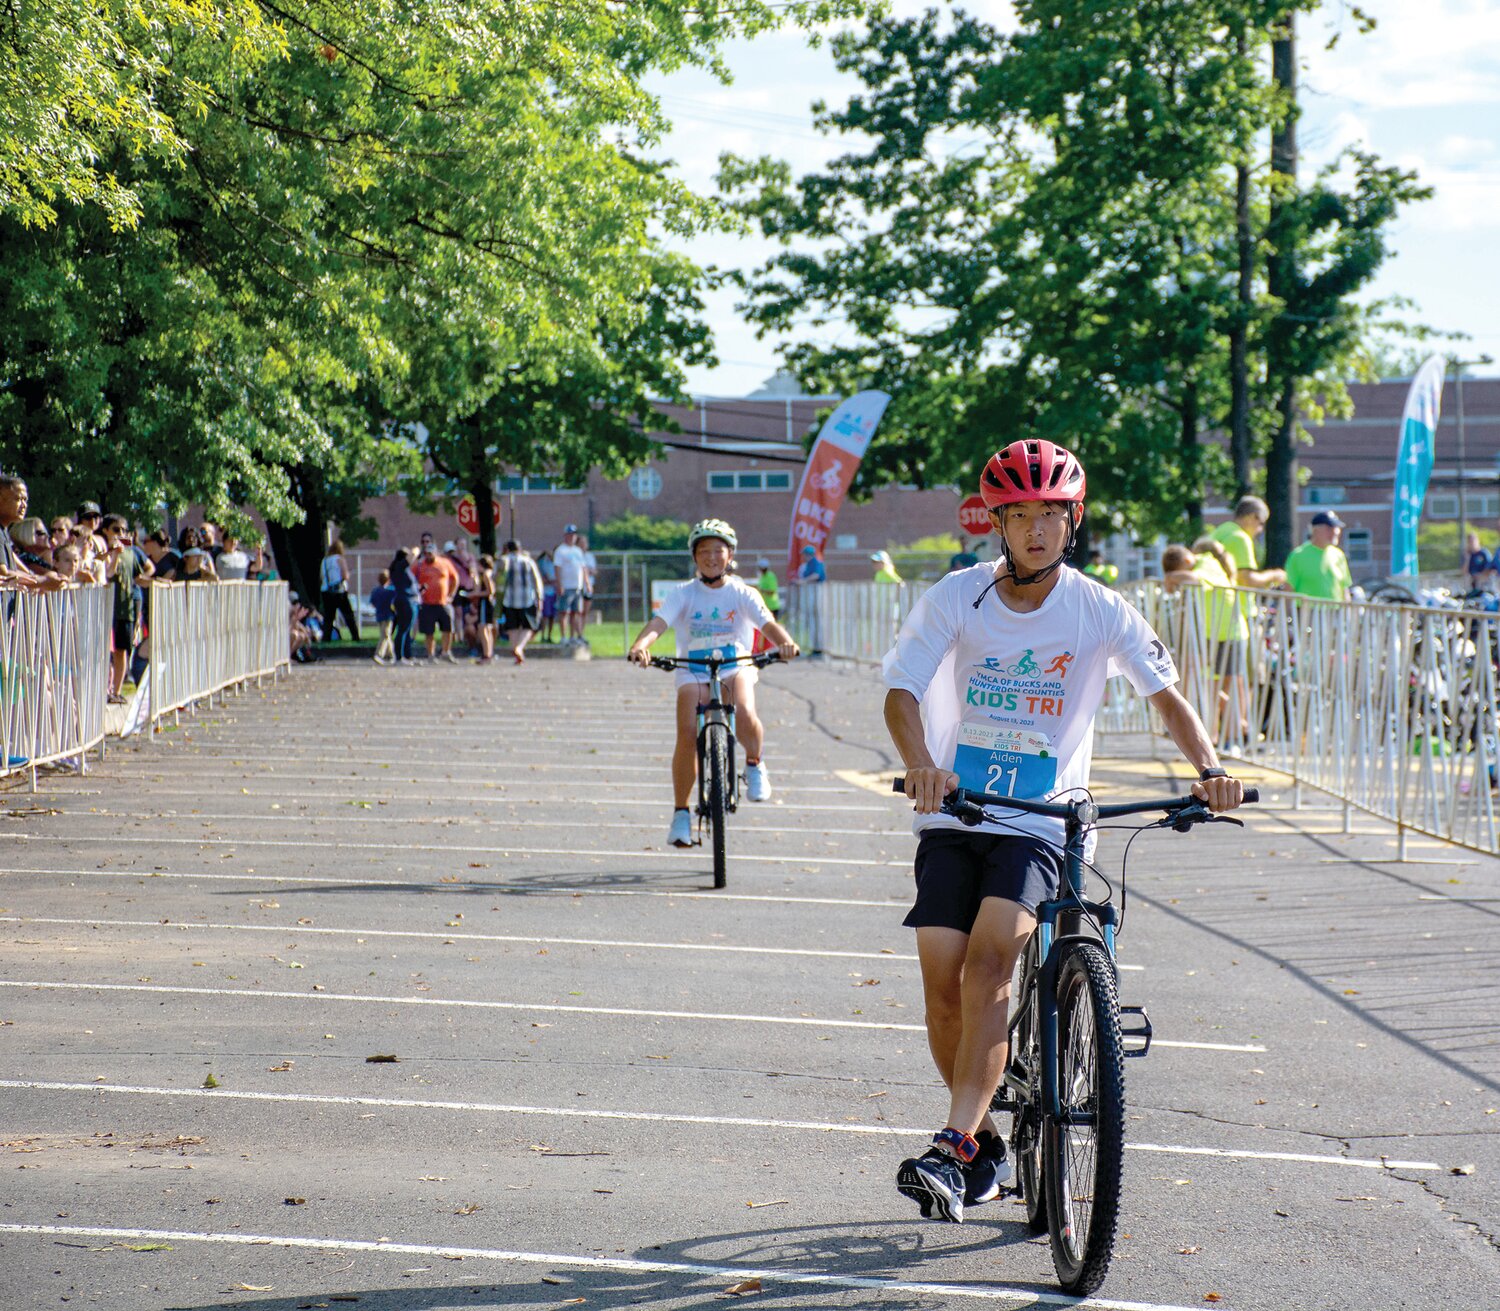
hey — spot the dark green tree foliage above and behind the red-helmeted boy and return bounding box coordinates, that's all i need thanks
[720,0,1413,546]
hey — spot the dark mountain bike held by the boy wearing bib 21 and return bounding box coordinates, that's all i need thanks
[894,779,1260,1298]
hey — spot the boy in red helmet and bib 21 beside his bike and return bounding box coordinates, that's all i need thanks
[885,441,1244,1224]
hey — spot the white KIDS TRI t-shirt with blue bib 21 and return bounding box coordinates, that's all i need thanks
[885,564,1178,851]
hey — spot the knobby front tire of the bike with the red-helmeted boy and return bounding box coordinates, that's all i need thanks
[1043,942,1125,1298]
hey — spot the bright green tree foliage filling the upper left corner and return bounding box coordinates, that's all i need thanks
[0,0,860,573]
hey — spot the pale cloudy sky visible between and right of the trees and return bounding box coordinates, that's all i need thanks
[657,0,1500,396]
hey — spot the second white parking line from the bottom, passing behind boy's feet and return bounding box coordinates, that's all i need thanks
[0,1079,1443,1170]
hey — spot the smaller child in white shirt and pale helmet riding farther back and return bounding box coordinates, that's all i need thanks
[626,519,798,846]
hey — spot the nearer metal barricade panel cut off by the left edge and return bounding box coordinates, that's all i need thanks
[0,585,114,786]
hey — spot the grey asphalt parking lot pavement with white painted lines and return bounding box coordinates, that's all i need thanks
[0,662,1500,1311]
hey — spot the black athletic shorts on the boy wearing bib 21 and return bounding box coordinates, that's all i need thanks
[902,828,1062,933]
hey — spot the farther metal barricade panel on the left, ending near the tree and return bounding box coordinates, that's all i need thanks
[147,582,291,728]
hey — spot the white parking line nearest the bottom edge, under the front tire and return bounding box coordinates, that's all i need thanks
[0,1224,1236,1311]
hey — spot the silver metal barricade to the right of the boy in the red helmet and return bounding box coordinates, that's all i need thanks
[1100,582,1500,857]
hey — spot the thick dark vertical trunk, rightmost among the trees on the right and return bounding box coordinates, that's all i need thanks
[1266,11,1298,567]
